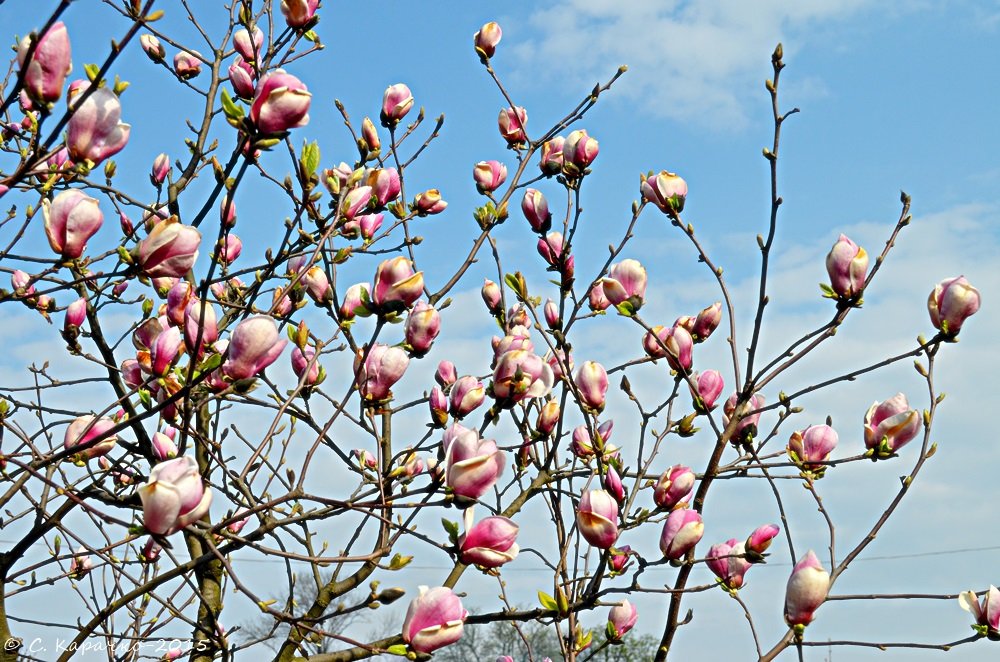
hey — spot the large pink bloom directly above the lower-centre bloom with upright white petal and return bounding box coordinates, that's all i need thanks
[444,425,505,499]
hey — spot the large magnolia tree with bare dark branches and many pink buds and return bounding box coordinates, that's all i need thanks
[0,0,988,662]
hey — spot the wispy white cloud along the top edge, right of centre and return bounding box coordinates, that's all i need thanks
[516,0,916,129]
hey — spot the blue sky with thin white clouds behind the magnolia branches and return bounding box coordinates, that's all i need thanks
[0,0,1000,660]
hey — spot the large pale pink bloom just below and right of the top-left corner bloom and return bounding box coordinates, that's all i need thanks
[66,87,132,164]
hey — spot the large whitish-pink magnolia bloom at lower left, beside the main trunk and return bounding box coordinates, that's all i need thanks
[137,456,212,536]
